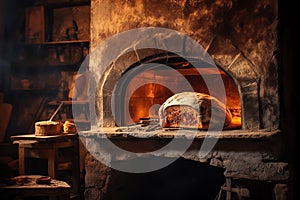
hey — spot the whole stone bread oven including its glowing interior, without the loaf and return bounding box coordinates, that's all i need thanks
[80,0,291,199]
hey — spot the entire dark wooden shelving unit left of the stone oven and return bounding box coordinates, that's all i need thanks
[9,0,90,135]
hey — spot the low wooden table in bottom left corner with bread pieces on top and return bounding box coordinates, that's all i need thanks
[0,175,71,200]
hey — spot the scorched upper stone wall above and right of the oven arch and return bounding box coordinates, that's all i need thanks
[91,0,279,129]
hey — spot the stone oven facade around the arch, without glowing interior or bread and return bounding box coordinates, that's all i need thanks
[81,0,291,199]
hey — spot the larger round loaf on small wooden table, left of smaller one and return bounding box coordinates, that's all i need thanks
[35,121,62,136]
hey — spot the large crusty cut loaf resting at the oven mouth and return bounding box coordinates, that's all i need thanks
[158,92,232,129]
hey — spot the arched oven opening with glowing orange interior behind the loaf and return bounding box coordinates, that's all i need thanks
[112,53,242,130]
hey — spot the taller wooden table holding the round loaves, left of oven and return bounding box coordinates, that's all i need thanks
[11,134,80,195]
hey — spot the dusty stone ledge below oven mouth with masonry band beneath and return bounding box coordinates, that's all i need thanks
[79,128,290,181]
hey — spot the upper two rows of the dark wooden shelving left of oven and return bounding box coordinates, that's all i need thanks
[13,0,90,72]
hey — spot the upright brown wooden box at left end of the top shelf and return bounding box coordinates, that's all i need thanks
[25,6,45,43]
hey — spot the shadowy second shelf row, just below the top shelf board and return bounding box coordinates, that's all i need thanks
[12,40,89,73]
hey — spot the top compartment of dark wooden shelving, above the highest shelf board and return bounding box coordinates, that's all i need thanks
[24,0,90,44]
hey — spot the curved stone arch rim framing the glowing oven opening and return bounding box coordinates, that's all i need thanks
[96,49,247,129]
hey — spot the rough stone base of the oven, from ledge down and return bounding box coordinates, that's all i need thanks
[81,130,292,200]
